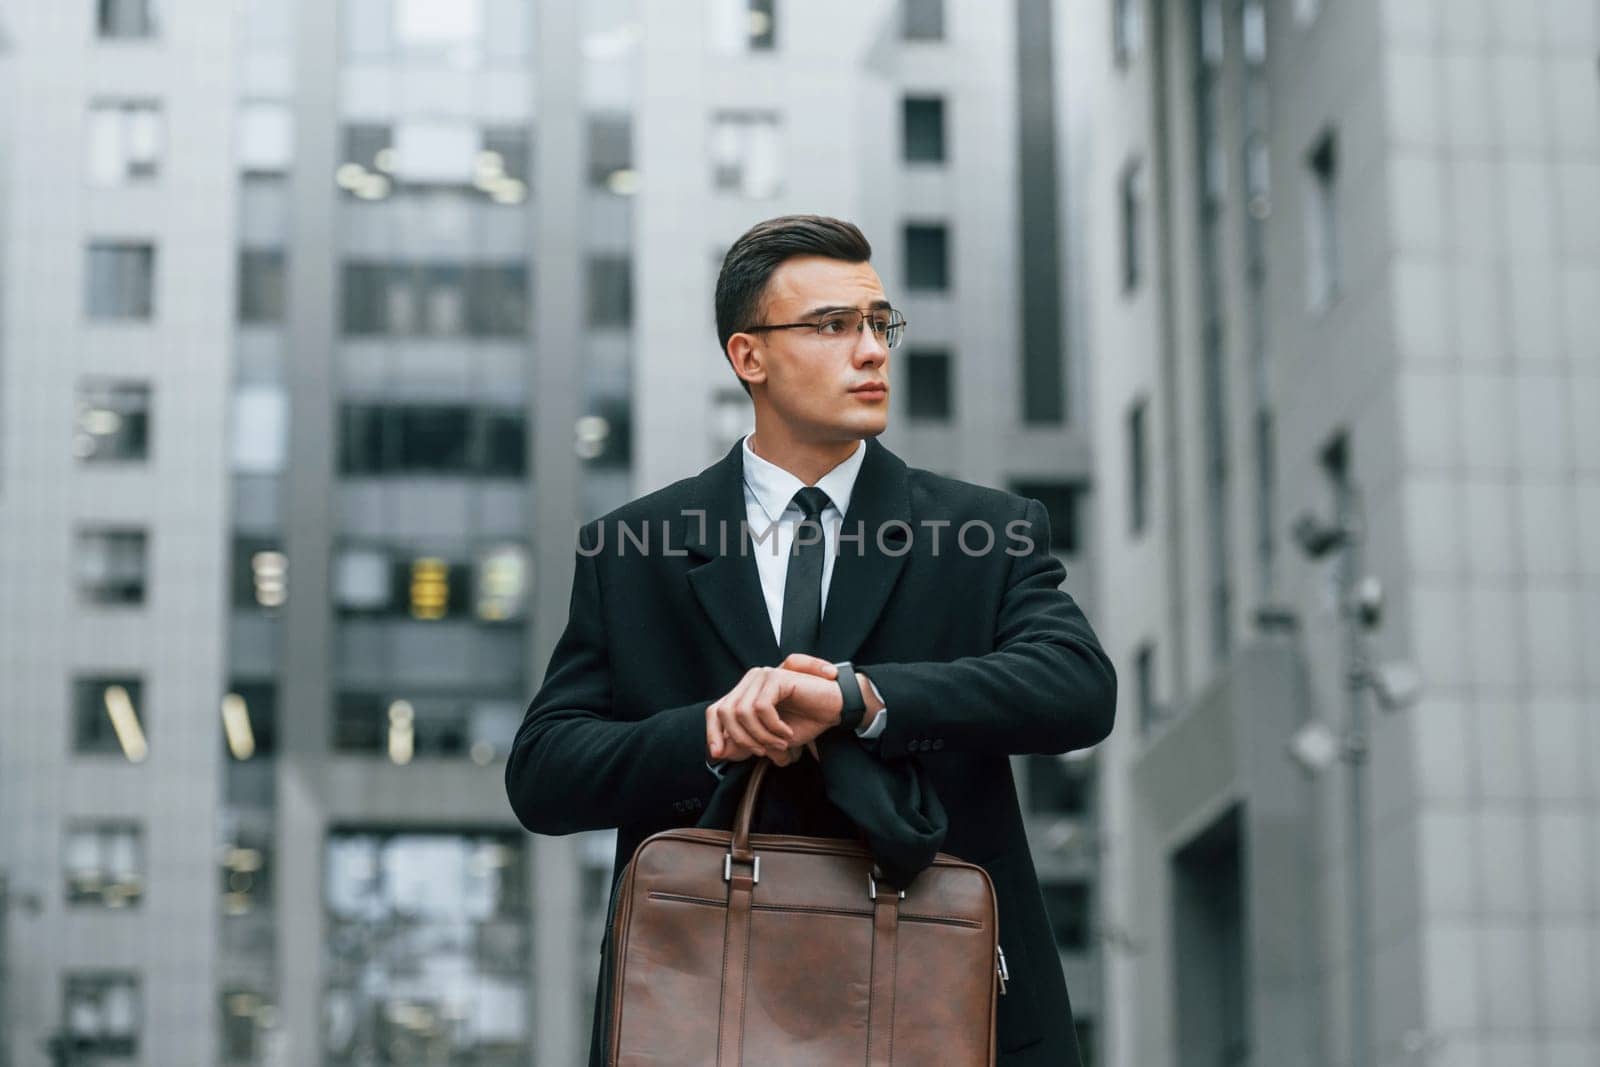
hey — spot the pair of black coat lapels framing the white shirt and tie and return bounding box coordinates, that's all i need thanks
[680,438,912,667]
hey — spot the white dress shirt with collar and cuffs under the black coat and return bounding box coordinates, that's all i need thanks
[707,434,888,776]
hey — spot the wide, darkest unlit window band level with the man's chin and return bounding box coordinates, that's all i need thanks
[339,403,528,477]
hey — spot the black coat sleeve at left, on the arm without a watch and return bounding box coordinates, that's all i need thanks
[506,525,717,833]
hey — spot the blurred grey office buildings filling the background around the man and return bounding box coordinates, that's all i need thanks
[0,0,1600,1067]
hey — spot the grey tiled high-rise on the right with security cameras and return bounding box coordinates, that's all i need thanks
[1061,0,1600,1067]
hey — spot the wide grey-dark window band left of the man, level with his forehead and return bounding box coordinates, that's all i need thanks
[341,262,528,338]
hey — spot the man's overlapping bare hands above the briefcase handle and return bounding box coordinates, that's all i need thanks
[706,656,843,766]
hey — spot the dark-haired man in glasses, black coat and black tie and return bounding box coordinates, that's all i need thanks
[506,216,1117,1067]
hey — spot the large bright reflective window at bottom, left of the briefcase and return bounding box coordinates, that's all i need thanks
[325,830,530,1067]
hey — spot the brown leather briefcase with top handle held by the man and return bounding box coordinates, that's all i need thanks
[605,760,1006,1067]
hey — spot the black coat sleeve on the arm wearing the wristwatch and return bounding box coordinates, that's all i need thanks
[858,501,1117,757]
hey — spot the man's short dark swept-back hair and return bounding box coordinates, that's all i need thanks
[717,214,872,371]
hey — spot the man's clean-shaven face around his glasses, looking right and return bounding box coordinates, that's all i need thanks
[730,256,890,443]
